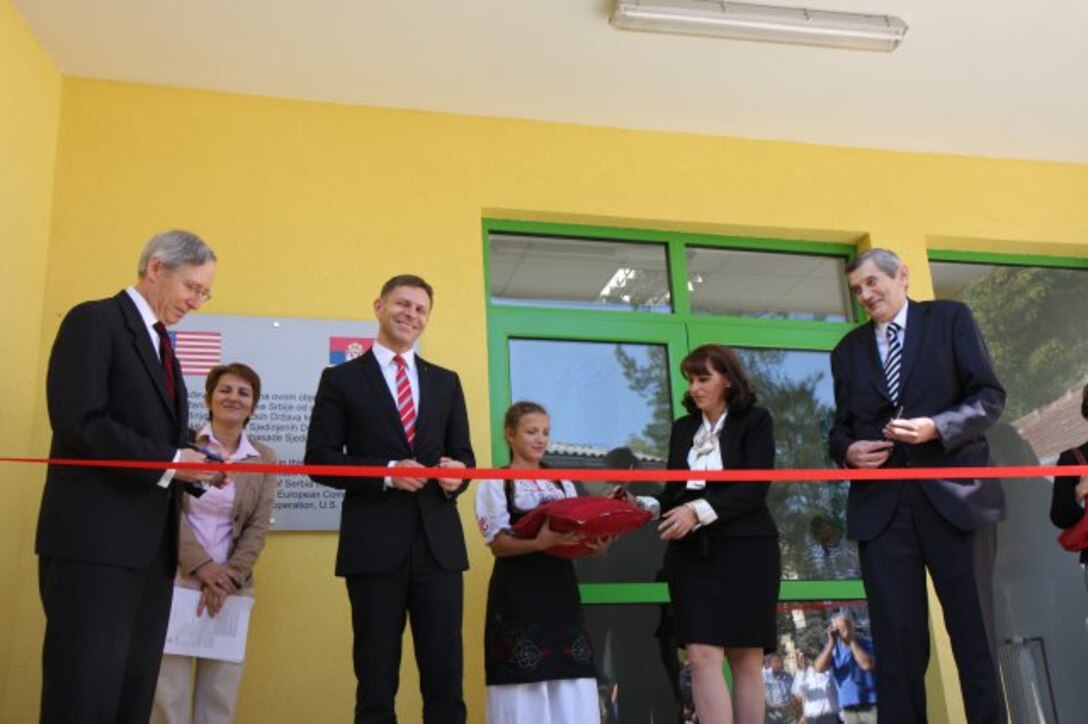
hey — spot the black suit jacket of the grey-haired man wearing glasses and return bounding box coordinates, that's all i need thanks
[35,292,188,567]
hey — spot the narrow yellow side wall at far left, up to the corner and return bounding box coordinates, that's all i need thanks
[0,0,61,722]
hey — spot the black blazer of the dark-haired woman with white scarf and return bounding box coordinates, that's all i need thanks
[658,406,778,544]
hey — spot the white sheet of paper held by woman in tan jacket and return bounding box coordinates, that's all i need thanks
[163,586,254,664]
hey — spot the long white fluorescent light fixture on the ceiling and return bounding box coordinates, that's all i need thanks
[609,0,906,52]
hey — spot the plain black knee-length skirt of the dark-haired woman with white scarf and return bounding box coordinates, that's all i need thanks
[665,531,782,652]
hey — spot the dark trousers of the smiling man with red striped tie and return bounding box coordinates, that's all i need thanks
[347,529,467,724]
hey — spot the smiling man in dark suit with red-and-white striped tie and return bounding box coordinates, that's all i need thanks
[306,274,475,724]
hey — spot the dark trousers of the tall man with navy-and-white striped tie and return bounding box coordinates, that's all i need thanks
[858,482,1003,724]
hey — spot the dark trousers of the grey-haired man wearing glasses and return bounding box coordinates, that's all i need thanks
[38,526,177,724]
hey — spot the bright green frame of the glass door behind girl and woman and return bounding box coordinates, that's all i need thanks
[482,218,865,605]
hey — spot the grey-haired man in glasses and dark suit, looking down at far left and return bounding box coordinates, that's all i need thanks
[36,231,215,724]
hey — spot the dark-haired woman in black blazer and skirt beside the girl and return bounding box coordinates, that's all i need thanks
[638,344,781,724]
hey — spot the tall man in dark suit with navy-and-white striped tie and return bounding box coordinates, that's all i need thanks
[829,249,1005,724]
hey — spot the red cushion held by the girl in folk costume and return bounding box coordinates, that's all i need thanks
[514,496,650,559]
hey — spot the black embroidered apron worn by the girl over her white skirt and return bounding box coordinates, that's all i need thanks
[484,553,596,686]
